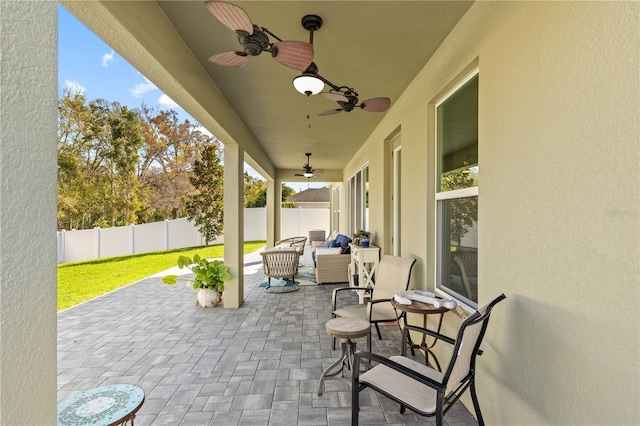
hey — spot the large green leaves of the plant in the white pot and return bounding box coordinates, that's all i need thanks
[162,254,231,293]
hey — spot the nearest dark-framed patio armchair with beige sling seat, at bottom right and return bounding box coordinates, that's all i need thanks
[351,294,505,426]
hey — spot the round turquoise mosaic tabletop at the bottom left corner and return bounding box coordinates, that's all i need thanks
[58,384,144,426]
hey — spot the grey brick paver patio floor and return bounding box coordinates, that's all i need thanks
[58,250,476,426]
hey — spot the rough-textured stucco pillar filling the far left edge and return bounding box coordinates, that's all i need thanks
[0,0,58,425]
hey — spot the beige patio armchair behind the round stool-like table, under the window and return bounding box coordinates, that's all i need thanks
[331,255,416,350]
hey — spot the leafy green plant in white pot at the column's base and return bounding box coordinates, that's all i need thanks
[162,254,231,308]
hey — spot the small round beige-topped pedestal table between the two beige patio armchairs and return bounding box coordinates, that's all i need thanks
[318,318,371,395]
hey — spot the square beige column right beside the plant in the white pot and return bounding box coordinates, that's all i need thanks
[223,144,244,308]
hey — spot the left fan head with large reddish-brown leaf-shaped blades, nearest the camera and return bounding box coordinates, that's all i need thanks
[204,1,313,71]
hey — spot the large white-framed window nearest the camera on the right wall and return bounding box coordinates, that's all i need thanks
[436,70,479,307]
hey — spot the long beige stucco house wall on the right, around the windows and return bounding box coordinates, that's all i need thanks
[344,2,640,425]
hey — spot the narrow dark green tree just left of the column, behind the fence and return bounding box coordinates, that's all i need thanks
[185,143,224,246]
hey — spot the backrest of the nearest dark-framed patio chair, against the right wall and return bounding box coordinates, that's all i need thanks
[443,294,506,394]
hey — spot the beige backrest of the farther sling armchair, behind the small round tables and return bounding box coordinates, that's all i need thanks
[373,255,416,299]
